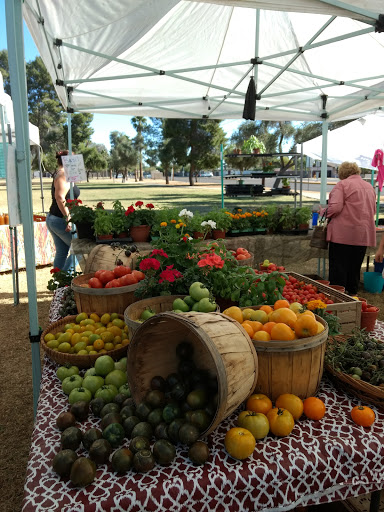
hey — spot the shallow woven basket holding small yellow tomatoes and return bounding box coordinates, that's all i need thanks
[40,315,128,368]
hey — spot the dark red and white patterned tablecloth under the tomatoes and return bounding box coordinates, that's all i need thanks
[22,328,384,512]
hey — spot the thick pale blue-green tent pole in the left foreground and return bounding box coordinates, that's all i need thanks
[5,0,41,415]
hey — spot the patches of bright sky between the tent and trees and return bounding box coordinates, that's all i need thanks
[0,0,241,149]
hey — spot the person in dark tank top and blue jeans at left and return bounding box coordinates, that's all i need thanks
[46,150,80,271]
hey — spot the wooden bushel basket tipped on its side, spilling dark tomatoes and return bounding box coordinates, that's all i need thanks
[127,312,258,436]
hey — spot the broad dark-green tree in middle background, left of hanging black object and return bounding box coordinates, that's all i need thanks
[163,119,225,186]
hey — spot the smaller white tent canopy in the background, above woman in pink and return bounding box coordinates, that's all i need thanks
[303,112,384,169]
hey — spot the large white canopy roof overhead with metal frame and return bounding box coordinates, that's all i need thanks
[23,0,384,121]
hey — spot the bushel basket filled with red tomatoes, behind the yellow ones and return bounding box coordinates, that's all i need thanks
[71,273,138,315]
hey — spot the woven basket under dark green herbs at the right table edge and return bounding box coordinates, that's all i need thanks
[324,335,384,410]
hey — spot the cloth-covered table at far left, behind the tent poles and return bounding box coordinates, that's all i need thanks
[0,222,56,272]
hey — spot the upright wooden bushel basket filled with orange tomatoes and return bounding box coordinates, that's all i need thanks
[253,315,328,401]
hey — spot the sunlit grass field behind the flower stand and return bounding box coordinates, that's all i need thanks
[0,178,314,213]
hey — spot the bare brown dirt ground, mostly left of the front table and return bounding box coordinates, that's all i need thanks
[0,260,384,512]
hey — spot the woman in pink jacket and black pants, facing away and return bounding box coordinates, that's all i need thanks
[326,162,376,295]
